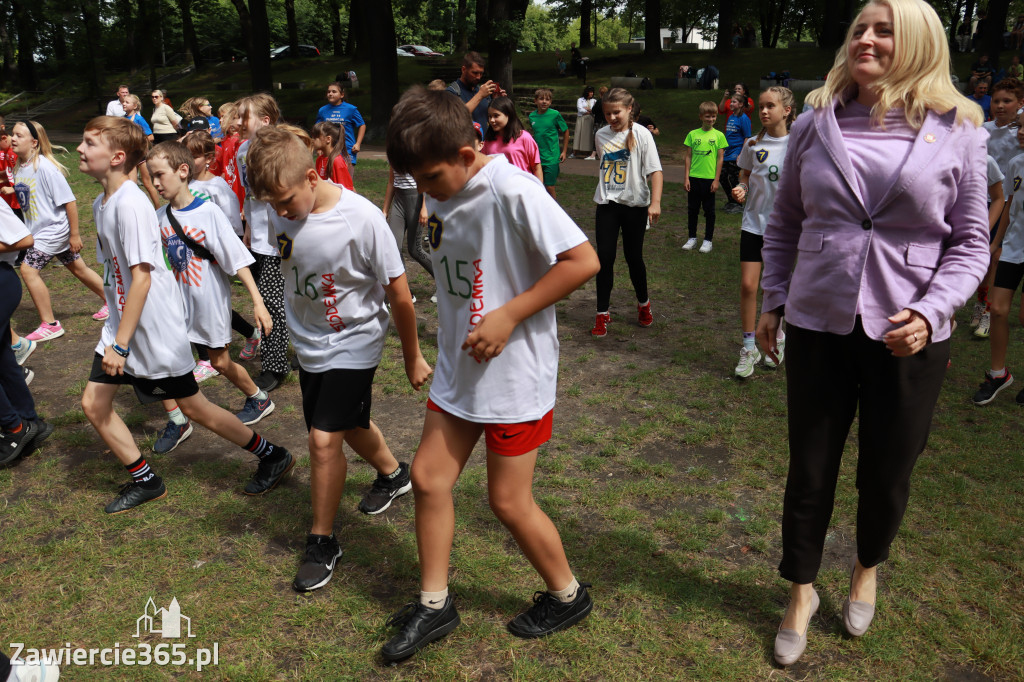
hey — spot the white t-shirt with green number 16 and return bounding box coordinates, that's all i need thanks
[270,185,406,372]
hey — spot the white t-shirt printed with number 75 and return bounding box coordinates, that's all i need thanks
[594,123,662,206]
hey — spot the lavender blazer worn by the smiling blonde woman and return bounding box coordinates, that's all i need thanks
[761,100,989,341]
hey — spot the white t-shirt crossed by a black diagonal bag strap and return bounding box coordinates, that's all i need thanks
[157,198,256,348]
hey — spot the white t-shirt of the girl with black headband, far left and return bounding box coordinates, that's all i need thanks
[14,156,75,256]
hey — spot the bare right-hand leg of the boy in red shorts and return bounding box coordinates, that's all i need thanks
[487,450,572,591]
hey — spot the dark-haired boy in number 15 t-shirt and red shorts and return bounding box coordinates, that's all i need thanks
[381,88,599,662]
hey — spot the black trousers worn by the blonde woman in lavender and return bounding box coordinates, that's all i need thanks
[778,317,949,584]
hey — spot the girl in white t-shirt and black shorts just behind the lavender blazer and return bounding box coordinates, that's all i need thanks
[732,85,797,378]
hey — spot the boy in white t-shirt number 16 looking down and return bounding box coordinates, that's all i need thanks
[248,128,431,592]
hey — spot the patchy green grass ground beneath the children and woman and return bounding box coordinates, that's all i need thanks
[0,155,1024,681]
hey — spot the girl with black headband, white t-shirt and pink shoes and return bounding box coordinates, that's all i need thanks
[11,121,108,341]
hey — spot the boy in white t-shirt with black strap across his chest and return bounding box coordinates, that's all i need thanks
[145,141,274,453]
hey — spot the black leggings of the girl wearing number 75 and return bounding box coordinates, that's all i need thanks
[595,202,647,312]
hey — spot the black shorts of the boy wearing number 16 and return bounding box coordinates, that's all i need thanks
[299,367,377,433]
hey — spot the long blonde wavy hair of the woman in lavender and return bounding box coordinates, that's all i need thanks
[807,0,984,129]
